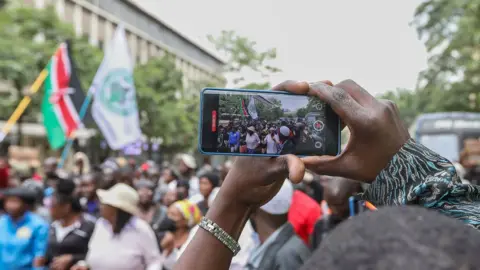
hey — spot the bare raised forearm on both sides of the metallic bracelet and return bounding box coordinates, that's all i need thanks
[174,190,250,270]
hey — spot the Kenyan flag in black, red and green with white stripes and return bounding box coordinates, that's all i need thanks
[42,42,85,149]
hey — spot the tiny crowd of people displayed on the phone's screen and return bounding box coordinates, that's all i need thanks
[217,119,314,155]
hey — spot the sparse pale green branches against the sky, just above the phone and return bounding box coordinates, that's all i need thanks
[208,31,281,87]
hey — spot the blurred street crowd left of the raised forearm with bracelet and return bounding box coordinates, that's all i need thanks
[0,152,228,270]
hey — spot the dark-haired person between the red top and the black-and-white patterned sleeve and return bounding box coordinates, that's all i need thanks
[310,176,362,250]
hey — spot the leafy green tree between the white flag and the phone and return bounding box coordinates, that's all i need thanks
[134,56,198,153]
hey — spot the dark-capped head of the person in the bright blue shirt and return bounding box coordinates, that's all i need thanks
[3,187,37,219]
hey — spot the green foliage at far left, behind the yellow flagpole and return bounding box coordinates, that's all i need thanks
[0,5,102,121]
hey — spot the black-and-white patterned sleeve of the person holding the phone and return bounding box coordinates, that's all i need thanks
[363,139,480,229]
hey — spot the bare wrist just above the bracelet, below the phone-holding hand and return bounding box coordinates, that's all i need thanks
[206,189,251,240]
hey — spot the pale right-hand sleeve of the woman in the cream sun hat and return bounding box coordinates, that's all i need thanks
[141,223,163,270]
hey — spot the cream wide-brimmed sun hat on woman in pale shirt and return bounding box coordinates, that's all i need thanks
[97,183,139,215]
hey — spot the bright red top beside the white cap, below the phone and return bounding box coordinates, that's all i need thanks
[288,190,322,245]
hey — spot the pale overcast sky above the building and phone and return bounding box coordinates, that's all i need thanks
[134,0,427,94]
